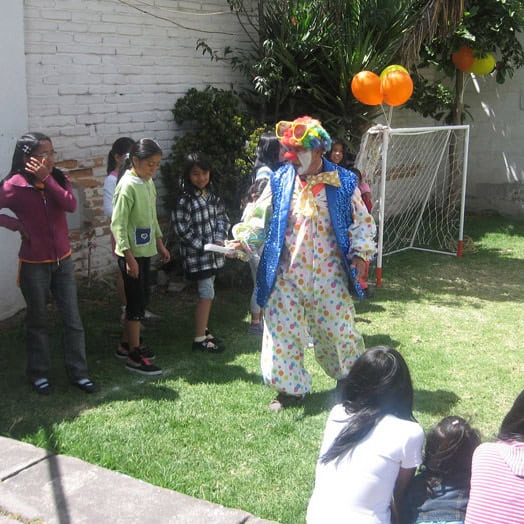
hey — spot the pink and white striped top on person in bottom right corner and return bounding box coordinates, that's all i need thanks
[465,441,524,524]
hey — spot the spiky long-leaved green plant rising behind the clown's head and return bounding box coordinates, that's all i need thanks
[199,0,462,143]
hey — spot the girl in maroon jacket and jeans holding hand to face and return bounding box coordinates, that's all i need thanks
[0,133,95,395]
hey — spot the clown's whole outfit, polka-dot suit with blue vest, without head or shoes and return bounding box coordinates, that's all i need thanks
[234,161,376,395]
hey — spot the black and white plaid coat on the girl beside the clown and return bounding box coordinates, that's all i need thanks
[173,191,229,276]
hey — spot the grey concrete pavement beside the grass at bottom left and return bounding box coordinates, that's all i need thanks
[0,436,275,524]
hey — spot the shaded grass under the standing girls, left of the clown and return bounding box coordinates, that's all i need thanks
[0,282,261,451]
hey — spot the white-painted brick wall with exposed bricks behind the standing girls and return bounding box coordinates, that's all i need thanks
[24,0,253,274]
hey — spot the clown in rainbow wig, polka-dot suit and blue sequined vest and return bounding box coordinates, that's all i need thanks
[232,116,376,411]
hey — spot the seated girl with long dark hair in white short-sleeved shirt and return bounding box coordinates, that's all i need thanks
[307,346,424,524]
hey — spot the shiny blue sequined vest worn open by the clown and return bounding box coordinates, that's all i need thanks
[256,159,370,307]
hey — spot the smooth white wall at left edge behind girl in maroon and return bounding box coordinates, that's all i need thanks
[0,2,27,320]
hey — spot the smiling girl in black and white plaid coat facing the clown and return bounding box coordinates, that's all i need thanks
[174,153,229,353]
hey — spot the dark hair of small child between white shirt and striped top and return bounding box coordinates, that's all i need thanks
[423,416,480,492]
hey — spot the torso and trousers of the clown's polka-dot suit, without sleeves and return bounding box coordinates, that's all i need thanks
[261,176,364,395]
